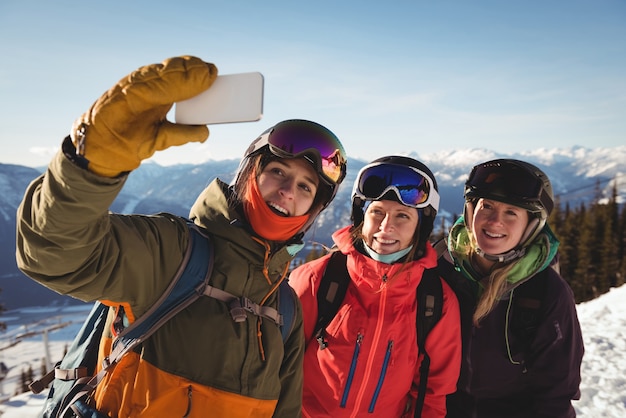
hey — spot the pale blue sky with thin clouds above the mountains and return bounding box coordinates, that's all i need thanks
[0,0,626,166]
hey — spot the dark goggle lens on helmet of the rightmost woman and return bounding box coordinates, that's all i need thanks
[467,164,542,200]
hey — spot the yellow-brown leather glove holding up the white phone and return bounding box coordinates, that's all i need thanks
[71,56,217,177]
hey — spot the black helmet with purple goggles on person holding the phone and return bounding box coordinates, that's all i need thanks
[231,119,347,236]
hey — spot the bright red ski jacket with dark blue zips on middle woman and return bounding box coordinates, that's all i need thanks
[289,227,461,418]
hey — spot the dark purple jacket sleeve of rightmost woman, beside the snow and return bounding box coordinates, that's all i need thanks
[528,273,584,418]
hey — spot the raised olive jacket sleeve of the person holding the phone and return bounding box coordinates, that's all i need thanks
[16,152,188,315]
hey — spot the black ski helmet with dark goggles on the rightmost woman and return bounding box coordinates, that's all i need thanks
[464,158,554,262]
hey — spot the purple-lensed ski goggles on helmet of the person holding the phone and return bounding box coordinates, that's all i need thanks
[246,120,347,185]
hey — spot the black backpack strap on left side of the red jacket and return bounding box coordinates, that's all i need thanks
[313,251,350,350]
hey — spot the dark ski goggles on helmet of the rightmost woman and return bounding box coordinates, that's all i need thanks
[465,161,553,211]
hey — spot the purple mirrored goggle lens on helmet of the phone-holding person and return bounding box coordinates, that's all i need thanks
[268,122,347,183]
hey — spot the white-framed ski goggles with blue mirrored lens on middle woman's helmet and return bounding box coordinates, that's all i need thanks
[353,163,439,210]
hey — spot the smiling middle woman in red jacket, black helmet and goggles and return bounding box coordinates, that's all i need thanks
[290,156,461,418]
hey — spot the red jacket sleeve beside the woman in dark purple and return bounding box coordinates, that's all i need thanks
[411,280,461,418]
